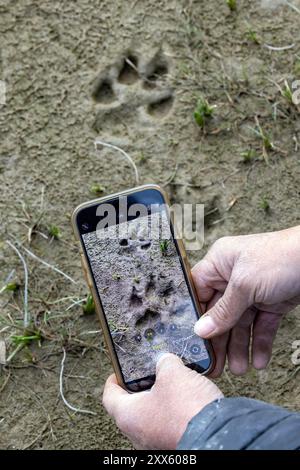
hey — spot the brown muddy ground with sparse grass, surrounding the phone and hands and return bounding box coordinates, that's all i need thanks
[0,0,300,449]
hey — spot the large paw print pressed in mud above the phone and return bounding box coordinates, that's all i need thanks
[92,51,174,131]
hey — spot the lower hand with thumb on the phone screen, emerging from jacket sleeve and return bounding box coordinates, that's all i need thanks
[103,354,223,450]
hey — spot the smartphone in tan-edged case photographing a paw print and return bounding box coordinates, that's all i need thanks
[72,185,214,392]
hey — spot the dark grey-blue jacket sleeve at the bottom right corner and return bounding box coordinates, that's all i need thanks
[177,398,300,450]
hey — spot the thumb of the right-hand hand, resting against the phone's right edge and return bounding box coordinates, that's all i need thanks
[194,282,252,338]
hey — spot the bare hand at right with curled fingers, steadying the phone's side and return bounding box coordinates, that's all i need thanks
[192,227,300,377]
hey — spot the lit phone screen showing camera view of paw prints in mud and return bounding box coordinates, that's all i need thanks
[81,189,211,391]
